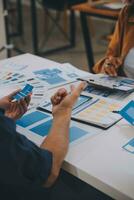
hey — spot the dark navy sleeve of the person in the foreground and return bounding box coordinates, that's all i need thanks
[0,111,52,185]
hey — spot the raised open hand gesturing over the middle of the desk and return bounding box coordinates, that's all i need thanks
[51,82,87,116]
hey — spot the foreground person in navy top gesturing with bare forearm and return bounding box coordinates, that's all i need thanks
[0,82,85,200]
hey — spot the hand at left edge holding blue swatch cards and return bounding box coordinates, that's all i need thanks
[5,95,31,120]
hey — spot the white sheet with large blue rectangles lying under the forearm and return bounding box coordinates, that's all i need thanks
[17,109,100,145]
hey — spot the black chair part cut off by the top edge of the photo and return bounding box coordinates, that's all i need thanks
[42,0,87,10]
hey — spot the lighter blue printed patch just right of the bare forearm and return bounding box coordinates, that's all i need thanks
[70,126,88,142]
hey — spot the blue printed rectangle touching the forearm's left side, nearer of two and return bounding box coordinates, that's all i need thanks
[30,120,52,137]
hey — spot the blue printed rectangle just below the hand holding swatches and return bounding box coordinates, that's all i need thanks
[17,111,49,128]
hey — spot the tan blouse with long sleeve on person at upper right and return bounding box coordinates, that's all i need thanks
[93,6,134,76]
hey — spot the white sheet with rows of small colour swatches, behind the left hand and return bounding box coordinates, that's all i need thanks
[0,61,47,109]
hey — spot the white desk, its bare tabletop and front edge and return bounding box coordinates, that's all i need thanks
[1,54,134,200]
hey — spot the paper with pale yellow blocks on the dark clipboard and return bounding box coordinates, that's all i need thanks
[72,97,121,129]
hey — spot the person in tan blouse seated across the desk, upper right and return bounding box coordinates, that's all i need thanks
[93,0,134,78]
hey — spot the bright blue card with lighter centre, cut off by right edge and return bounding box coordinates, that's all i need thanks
[119,101,134,125]
